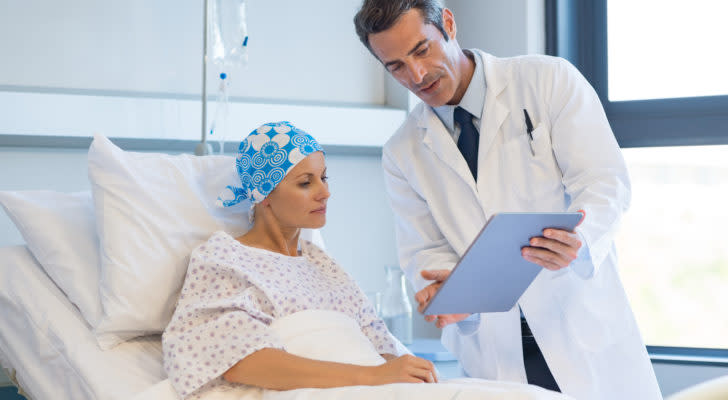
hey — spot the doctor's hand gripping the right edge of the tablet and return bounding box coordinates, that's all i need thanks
[521,210,586,271]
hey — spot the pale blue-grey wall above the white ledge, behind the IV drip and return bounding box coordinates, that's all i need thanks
[0,0,385,104]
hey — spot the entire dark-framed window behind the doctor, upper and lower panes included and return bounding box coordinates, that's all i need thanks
[546,0,728,354]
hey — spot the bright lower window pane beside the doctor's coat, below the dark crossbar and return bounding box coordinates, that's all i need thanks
[616,146,728,349]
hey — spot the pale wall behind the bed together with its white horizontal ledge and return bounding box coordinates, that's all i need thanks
[0,0,406,146]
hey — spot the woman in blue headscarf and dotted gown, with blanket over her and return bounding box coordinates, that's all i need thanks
[162,121,562,399]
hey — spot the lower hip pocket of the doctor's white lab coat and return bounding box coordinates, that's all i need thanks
[556,270,630,353]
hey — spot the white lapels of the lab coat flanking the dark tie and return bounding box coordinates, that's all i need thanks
[414,50,510,191]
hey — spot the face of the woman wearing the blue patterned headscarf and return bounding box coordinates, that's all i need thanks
[268,151,331,228]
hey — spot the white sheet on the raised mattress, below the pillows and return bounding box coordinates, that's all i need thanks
[0,246,166,400]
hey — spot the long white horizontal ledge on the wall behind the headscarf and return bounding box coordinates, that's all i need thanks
[0,91,406,148]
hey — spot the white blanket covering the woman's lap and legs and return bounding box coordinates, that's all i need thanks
[133,310,568,400]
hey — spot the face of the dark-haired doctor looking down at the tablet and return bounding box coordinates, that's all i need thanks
[369,9,469,107]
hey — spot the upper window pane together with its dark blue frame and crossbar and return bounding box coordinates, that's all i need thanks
[546,0,728,147]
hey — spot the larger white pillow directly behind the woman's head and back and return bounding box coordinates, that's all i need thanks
[88,135,323,348]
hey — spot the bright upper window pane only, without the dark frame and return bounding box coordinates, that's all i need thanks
[607,0,728,101]
